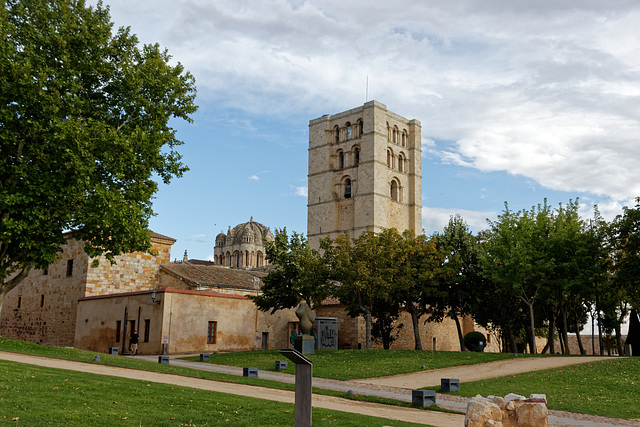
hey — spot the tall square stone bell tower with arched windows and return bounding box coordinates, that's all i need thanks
[307,101,422,249]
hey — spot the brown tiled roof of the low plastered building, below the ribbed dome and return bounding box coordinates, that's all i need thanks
[161,263,266,290]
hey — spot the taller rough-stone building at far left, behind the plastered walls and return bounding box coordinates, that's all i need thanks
[0,233,175,347]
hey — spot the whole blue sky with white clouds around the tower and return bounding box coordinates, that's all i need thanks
[92,0,640,259]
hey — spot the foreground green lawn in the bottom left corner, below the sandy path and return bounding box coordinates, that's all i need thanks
[0,361,430,427]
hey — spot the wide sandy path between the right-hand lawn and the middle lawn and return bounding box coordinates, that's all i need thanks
[353,356,611,389]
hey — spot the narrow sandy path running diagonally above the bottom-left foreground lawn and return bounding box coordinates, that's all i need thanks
[0,351,464,427]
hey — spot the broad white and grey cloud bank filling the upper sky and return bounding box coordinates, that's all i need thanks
[100,0,640,204]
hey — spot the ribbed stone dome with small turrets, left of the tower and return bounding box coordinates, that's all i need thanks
[213,217,274,269]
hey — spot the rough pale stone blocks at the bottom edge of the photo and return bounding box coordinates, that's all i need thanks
[464,393,549,427]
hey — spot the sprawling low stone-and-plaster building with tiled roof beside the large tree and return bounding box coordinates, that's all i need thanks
[0,233,298,354]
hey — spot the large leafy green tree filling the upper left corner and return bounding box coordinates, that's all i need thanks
[0,0,197,308]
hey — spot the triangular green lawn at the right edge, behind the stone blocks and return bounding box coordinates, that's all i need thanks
[425,357,640,419]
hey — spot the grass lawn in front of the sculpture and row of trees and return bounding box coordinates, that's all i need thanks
[181,350,514,380]
